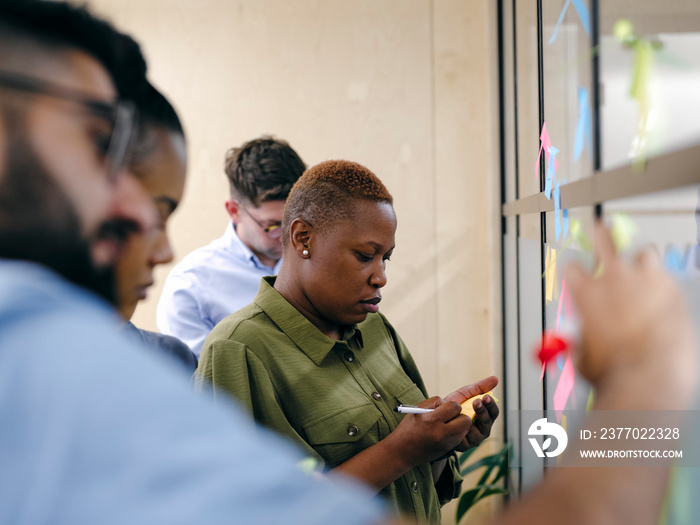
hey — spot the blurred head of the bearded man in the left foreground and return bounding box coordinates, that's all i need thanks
[0,9,156,300]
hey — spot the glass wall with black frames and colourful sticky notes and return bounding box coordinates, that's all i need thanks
[499,0,700,502]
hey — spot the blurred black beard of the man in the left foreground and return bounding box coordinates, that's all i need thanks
[0,114,116,304]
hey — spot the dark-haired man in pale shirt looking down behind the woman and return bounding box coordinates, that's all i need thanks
[156,137,305,356]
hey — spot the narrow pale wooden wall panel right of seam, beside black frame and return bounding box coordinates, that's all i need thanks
[433,0,503,523]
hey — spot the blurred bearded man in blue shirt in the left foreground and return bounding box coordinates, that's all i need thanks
[0,0,382,524]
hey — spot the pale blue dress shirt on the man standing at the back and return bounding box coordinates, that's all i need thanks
[156,223,282,356]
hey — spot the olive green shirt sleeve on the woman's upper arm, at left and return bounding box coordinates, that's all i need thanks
[194,339,323,463]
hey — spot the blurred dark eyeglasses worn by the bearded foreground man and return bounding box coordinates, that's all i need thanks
[0,71,137,181]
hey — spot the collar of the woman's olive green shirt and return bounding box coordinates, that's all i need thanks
[254,277,363,366]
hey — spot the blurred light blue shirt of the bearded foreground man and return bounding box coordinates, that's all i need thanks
[0,261,383,525]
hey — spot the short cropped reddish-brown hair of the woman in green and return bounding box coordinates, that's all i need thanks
[282,160,394,247]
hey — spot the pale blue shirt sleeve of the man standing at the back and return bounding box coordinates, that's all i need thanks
[156,274,214,356]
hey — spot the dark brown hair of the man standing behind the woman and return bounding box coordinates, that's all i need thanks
[225,136,306,206]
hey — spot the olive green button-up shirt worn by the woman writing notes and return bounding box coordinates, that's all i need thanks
[195,277,462,523]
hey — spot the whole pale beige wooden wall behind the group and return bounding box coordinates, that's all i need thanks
[83,0,501,523]
